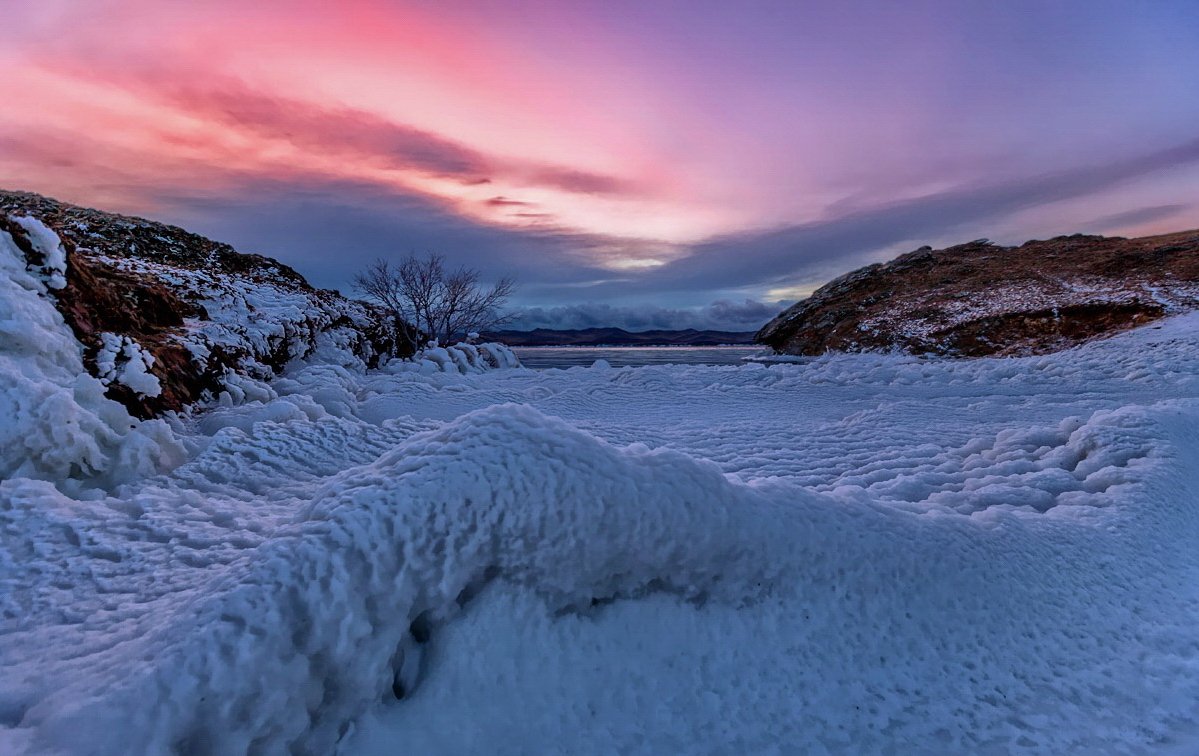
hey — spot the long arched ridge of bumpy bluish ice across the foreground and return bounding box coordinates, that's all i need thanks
[11,395,1194,755]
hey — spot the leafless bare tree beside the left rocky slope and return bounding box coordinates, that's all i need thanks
[354,254,516,347]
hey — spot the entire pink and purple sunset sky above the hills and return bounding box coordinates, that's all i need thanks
[0,0,1199,329]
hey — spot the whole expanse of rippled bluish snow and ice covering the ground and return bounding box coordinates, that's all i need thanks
[0,263,1199,755]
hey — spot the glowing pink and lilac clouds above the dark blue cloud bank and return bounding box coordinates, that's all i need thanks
[0,0,1199,283]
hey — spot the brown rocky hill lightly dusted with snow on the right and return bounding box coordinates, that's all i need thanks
[757,230,1199,357]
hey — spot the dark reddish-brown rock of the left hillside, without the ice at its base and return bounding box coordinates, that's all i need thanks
[0,190,411,418]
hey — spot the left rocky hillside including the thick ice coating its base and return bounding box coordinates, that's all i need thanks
[0,192,519,490]
